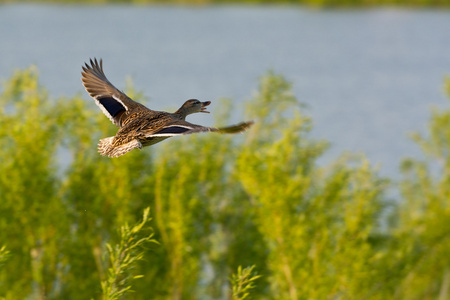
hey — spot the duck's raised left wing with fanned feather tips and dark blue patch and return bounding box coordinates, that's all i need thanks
[81,58,147,126]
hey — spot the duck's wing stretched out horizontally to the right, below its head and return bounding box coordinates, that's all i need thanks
[143,121,253,138]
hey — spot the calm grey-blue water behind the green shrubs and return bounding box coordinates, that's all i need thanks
[0,4,450,177]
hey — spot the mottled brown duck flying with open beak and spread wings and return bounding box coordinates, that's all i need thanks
[81,58,253,157]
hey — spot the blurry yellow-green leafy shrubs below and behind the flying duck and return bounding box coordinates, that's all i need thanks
[0,68,450,300]
